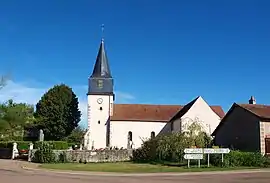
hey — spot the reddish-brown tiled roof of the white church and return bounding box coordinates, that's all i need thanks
[111,104,224,122]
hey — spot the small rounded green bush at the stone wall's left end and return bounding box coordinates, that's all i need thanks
[33,142,56,163]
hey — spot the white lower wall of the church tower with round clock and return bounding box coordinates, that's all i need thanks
[84,95,113,149]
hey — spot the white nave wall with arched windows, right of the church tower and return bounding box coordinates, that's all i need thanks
[111,121,166,148]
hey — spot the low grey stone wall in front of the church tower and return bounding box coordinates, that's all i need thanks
[28,149,132,163]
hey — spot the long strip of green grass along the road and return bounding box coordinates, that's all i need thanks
[40,162,255,173]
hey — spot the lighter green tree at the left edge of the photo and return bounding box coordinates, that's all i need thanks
[0,100,34,140]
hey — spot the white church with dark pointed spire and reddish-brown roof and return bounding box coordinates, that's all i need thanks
[84,39,225,150]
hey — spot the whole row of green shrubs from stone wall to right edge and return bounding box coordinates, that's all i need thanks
[132,134,270,167]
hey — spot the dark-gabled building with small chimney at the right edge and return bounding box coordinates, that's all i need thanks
[212,97,270,154]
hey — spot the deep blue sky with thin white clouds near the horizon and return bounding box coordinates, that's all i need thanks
[0,0,270,126]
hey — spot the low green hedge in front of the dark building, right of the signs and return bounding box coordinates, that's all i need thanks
[210,151,269,167]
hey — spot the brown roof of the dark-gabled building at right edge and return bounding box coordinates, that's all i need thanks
[212,103,270,136]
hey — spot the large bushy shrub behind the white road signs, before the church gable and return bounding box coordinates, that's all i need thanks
[133,127,211,162]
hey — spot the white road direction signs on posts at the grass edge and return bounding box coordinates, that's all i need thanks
[184,148,230,168]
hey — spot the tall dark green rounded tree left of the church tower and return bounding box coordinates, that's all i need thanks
[35,84,81,140]
